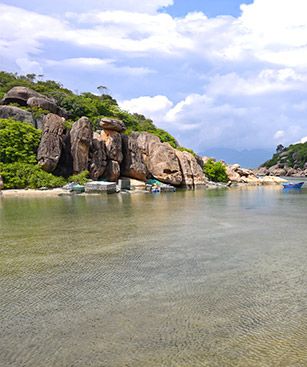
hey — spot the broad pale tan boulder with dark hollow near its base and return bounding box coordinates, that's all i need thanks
[146,141,182,186]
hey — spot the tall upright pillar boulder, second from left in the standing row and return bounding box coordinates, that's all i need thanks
[70,117,93,173]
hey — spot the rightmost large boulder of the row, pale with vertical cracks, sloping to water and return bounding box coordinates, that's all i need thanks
[176,150,206,189]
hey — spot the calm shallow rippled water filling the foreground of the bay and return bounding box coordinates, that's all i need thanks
[0,187,307,367]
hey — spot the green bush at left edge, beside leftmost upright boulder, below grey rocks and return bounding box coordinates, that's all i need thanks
[0,119,41,164]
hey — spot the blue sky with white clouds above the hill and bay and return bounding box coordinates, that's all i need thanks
[0,0,307,160]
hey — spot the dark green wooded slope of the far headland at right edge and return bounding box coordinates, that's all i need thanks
[262,143,307,168]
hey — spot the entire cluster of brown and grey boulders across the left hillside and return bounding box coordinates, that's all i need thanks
[0,87,206,188]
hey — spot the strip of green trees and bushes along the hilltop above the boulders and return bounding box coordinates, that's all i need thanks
[0,71,183,148]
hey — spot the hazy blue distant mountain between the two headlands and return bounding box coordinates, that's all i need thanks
[199,148,274,168]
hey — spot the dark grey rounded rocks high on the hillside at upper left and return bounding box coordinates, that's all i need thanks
[0,86,67,129]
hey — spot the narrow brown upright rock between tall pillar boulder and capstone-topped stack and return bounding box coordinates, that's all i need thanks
[89,133,107,180]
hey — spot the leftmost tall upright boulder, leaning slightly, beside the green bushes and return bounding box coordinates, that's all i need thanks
[37,113,64,172]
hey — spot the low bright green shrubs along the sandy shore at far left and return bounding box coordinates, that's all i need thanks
[0,162,66,189]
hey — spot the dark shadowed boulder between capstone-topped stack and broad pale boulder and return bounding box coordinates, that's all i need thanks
[121,132,149,181]
